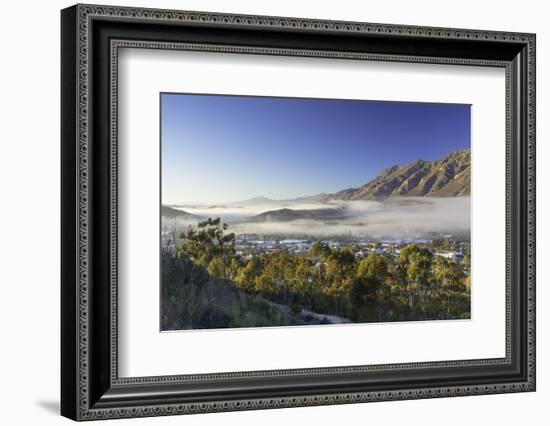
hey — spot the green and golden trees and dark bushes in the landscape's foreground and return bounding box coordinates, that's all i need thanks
[162,218,470,330]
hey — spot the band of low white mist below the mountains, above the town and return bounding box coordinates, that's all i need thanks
[163,197,470,238]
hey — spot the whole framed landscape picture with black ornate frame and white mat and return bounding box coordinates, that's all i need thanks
[61,5,535,420]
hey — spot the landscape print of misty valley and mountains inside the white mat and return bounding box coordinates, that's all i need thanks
[160,93,472,331]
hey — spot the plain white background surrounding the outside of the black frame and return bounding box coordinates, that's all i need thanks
[0,0,550,426]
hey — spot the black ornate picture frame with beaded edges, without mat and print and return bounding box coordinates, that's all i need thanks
[61,5,535,420]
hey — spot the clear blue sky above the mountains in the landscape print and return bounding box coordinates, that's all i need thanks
[161,93,470,204]
